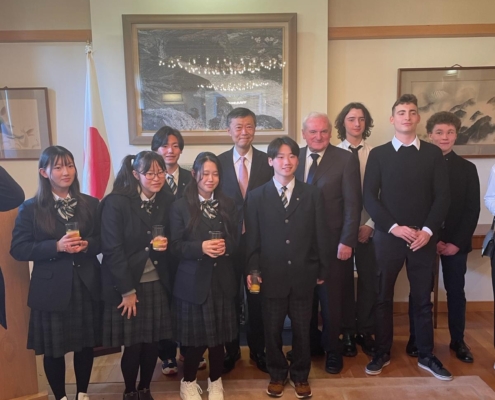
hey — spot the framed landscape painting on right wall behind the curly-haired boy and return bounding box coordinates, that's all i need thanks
[398,67,495,158]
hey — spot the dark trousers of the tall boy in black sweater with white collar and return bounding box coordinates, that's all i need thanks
[374,231,436,355]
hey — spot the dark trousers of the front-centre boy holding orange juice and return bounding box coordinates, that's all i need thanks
[260,294,313,383]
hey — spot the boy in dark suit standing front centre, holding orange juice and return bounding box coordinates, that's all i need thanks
[246,136,330,399]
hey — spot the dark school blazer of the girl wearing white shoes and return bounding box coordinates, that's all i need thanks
[170,198,238,304]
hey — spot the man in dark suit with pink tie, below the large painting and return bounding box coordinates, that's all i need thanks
[218,107,273,373]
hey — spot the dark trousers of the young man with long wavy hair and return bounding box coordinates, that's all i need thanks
[342,238,378,335]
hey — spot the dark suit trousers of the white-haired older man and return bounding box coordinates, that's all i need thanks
[311,253,353,354]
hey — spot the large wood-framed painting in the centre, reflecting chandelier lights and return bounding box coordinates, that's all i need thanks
[122,14,297,145]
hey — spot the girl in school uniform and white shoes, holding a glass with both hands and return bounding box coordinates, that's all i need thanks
[170,152,237,400]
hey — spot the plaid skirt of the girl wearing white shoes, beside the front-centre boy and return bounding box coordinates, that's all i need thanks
[173,279,238,347]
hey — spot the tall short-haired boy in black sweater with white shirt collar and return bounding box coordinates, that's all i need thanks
[363,94,452,380]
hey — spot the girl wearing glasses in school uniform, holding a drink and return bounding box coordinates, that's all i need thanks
[101,151,174,400]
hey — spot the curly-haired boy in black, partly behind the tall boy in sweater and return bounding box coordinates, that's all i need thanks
[406,111,480,363]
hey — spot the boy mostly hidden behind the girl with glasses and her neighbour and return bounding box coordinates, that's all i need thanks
[151,125,197,376]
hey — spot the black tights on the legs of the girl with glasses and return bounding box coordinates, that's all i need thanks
[120,343,158,393]
